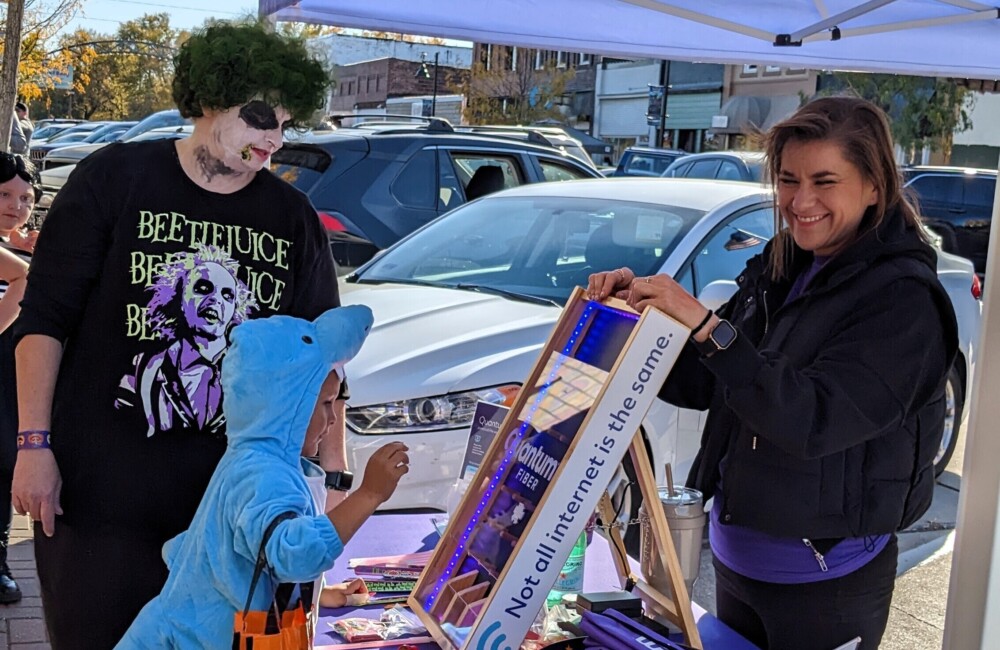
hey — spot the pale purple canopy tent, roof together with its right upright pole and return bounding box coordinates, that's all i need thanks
[259,0,1000,650]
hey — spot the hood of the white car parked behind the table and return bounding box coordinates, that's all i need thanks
[341,283,561,406]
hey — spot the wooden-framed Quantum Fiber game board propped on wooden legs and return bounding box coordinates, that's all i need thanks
[408,288,701,650]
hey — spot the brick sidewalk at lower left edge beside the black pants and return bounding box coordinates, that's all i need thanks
[0,515,49,650]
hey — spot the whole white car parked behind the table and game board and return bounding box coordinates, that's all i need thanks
[341,178,980,516]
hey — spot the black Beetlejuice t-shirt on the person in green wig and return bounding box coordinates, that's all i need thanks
[15,140,340,539]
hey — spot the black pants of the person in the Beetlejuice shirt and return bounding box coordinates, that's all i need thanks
[35,522,167,650]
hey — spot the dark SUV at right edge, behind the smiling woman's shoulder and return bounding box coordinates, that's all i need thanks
[903,166,997,275]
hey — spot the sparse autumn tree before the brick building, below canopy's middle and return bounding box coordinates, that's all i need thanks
[456,59,576,124]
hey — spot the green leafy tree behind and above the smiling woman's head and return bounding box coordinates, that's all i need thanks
[821,72,972,160]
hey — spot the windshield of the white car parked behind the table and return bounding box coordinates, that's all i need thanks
[356,196,704,303]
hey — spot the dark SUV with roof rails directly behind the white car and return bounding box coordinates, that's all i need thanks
[271,118,601,267]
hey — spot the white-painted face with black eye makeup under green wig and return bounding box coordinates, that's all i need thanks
[211,100,291,173]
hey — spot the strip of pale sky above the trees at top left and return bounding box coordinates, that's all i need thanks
[56,0,257,33]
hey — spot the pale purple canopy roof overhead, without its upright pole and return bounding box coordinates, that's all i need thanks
[260,0,1000,79]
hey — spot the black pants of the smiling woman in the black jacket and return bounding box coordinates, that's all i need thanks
[713,535,899,650]
